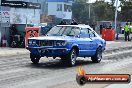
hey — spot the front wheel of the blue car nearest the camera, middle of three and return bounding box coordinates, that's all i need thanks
[67,49,77,66]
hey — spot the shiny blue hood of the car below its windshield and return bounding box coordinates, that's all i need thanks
[29,36,75,40]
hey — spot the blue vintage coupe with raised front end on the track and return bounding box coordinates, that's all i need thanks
[27,25,106,66]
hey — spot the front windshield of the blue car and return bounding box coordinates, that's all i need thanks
[47,26,80,36]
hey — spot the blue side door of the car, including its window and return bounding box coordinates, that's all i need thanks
[78,28,92,56]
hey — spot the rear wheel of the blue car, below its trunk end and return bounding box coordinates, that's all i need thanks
[91,47,103,63]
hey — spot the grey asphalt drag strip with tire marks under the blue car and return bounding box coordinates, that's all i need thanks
[0,43,132,88]
